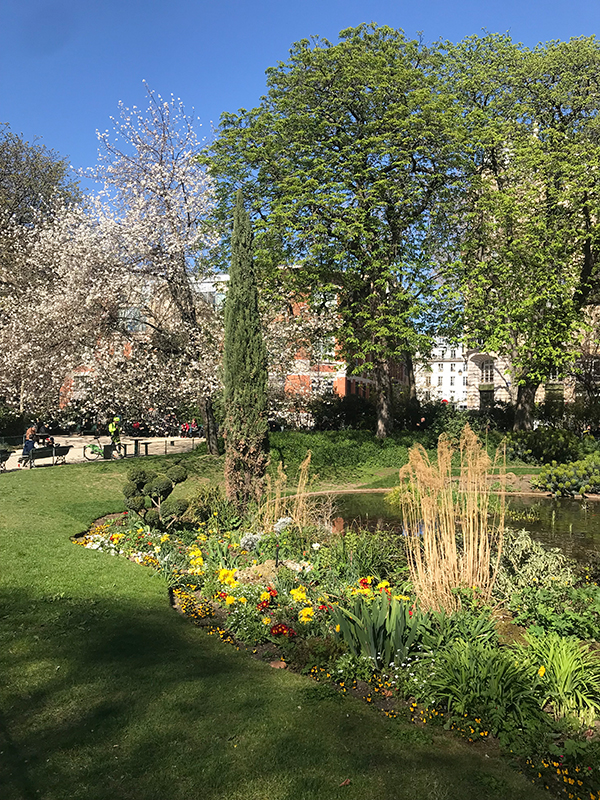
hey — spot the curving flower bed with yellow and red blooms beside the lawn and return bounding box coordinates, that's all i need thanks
[78,511,600,800]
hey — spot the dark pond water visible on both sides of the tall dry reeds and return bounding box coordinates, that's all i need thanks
[336,492,600,560]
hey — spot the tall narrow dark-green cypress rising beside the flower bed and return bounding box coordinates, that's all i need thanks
[223,191,268,509]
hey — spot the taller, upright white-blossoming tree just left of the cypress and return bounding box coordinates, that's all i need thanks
[89,88,220,452]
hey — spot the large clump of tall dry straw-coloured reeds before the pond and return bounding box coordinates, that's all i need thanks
[398,425,506,611]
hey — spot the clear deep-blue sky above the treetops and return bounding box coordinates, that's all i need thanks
[0,0,600,178]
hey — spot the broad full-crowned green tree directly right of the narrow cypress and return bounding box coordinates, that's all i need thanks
[208,24,459,437]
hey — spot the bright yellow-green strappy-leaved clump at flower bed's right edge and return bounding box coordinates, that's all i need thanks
[525,633,600,725]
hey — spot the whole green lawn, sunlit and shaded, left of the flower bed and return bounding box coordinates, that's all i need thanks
[0,462,547,800]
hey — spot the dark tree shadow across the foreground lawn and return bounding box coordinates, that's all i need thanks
[0,590,541,800]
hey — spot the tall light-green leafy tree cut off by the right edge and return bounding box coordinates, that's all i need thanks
[444,35,600,429]
